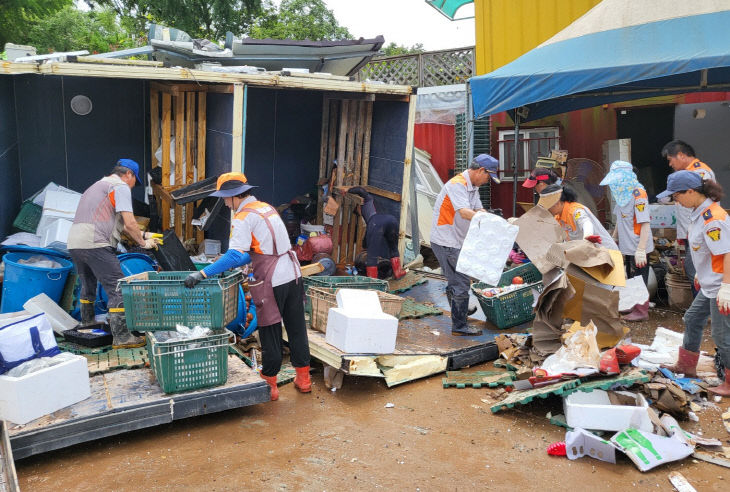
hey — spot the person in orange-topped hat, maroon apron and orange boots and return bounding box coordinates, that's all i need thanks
[185,172,312,400]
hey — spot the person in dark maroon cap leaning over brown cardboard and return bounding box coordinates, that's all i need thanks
[537,184,618,250]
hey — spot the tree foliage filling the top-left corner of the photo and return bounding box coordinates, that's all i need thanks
[0,0,73,47]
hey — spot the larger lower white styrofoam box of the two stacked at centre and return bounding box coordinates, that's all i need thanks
[325,308,398,354]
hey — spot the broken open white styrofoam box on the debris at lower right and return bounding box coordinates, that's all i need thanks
[563,390,654,432]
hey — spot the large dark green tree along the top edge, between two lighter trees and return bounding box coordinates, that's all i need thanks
[94,0,264,41]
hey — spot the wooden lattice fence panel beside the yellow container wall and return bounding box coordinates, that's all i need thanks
[358,47,474,87]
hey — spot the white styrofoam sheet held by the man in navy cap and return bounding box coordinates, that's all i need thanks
[456,212,520,285]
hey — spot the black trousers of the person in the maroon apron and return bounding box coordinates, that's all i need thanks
[259,278,309,376]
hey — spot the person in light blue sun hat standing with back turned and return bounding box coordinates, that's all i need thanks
[601,161,654,321]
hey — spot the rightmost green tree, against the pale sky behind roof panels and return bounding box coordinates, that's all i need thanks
[249,0,352,41]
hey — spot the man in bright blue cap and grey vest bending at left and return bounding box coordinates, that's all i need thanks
[68,159,157,348]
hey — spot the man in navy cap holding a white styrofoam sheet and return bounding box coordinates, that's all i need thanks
[431,154,499,335]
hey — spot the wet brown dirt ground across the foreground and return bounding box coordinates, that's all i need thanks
[16,310,730,491]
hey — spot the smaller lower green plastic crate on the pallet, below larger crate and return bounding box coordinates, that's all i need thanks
[147,330,230,393]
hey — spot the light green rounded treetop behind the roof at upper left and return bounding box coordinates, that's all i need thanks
[30,7,135,54]
